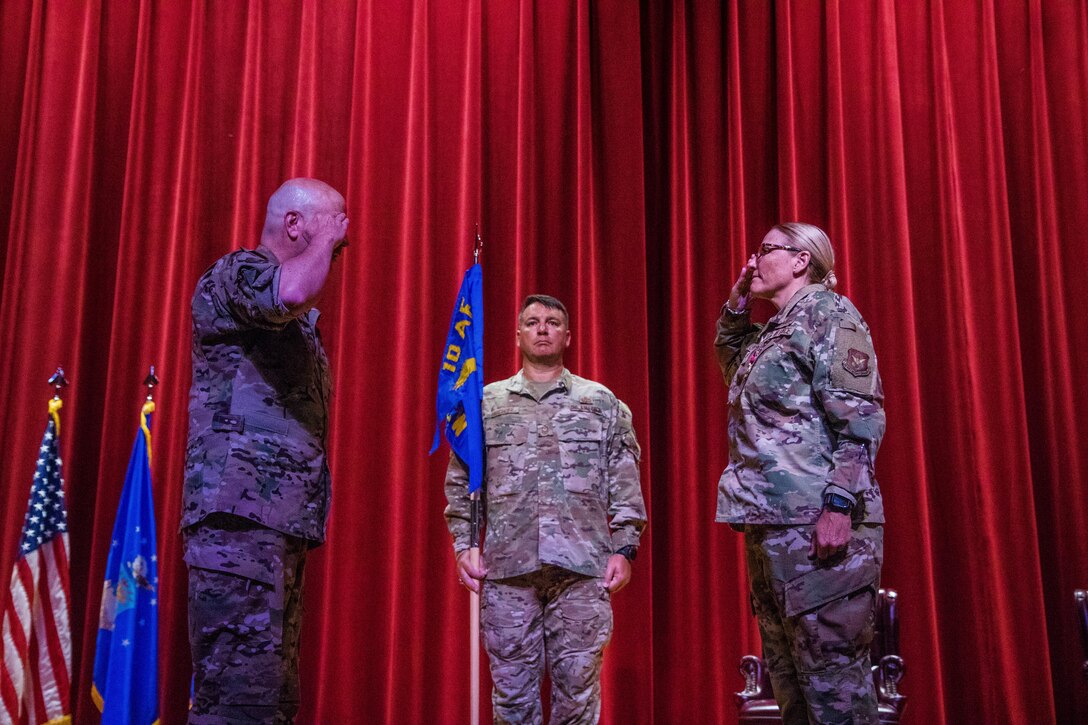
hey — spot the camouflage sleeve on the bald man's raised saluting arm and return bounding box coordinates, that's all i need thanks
[205,251,295,330]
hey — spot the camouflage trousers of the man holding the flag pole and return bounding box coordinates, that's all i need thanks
[480,566,613,725]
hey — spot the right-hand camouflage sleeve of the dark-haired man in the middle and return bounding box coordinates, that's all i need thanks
[608,401,646,551]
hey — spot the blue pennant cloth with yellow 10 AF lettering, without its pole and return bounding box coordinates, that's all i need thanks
[431,265,483,493]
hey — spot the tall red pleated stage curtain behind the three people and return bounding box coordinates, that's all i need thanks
[0,0,1088,723]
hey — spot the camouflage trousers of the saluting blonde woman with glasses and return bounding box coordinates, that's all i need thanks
[744,526,883,723]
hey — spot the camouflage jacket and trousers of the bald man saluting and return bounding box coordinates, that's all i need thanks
[181,247,331,723]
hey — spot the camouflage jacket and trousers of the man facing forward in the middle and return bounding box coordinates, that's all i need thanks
[445,370,646,723]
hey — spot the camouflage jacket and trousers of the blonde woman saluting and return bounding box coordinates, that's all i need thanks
[715,284,885,723]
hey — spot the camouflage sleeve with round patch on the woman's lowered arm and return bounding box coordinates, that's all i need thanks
[813,316,885,503]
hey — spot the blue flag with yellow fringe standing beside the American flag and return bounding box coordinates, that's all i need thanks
[91,401,159,725]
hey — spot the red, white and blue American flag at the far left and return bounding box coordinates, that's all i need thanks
[0,407,72,723]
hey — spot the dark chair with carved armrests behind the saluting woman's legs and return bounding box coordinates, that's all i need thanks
[735,589,905,725]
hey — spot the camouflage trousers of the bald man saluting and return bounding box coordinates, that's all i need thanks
[184,515,307,725]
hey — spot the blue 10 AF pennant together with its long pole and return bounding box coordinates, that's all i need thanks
[431,224,484,725]
